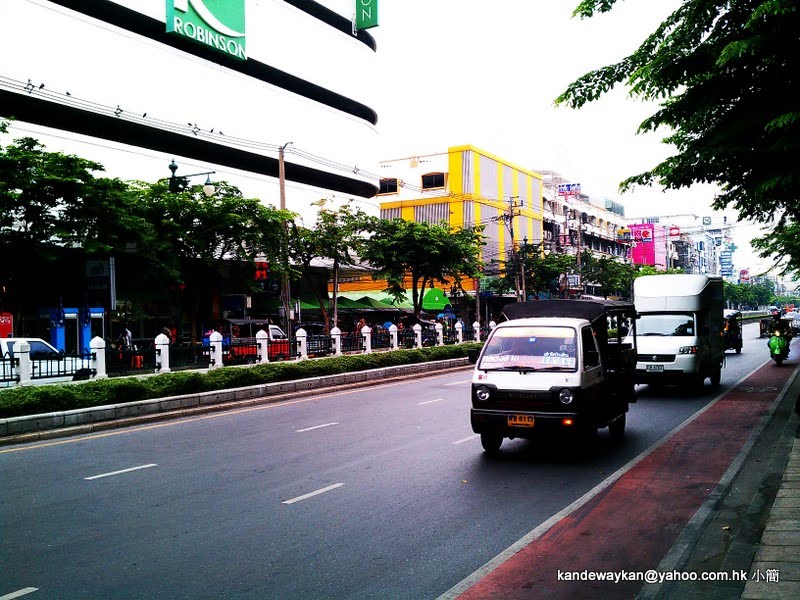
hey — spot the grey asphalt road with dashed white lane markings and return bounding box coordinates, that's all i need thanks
[0,325,767,600]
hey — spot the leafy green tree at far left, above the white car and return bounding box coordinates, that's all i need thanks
[0,131,141,318]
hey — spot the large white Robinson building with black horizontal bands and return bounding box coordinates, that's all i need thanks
[0,0,377,336]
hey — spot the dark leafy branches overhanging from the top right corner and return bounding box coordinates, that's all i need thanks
[556,0,800,274]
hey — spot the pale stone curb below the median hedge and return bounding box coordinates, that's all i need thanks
[0,358,472,446]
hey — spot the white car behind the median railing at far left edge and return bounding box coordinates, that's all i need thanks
[0,338,91,387]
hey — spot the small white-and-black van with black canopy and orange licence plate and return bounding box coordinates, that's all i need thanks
[470,300,636,454]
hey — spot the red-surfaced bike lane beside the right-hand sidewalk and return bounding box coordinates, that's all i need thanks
[458,362,794,600]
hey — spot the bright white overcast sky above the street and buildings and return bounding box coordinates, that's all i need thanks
[0,0,776,271]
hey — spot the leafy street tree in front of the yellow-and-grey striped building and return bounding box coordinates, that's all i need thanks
[362,219,484,317]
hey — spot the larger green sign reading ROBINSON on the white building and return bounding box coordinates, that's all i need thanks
[167,0,247,60]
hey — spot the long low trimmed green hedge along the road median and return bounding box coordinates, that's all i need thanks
[0,342,481,418]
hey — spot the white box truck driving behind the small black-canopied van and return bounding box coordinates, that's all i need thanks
[633,274,725,390]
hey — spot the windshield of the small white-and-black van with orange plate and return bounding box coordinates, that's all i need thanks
[478,326,577,371]
